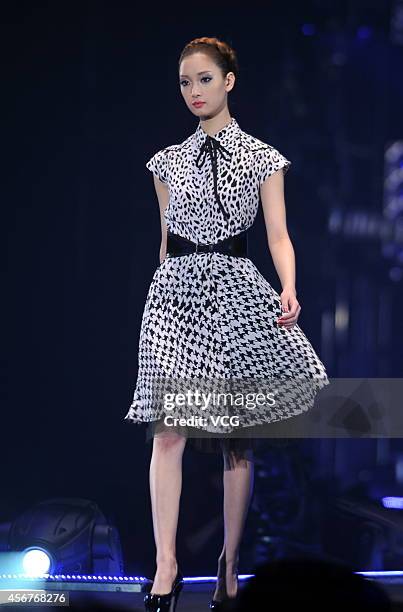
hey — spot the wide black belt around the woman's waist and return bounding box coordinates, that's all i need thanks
[167,230,248,257]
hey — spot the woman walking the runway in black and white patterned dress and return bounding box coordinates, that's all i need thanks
[124,38,329,610]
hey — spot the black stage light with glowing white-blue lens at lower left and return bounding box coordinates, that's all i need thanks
[0,498,124,576]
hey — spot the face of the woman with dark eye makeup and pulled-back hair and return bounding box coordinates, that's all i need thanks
[179,52,235,119]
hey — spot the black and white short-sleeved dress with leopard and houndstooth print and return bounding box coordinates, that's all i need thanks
[124,117,329,451]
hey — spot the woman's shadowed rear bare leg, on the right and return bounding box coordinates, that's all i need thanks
[213,449,254,600]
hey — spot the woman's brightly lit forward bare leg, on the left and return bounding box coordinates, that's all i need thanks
[150,433,186,595]
